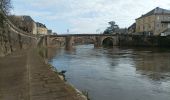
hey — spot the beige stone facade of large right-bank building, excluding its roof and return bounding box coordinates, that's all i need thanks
[136,14,170,35]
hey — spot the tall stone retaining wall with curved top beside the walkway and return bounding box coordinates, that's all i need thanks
[0,13,36,57]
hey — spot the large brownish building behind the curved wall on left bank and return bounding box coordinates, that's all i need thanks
[8,15,37,34]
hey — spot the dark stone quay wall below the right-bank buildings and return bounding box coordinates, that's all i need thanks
[119,35,170,47]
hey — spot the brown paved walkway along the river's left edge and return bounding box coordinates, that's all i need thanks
[0,50,85,100]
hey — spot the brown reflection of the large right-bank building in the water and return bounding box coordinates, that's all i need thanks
[135,51,170,81]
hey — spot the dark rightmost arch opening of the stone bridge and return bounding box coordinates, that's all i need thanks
[102,37,114,47]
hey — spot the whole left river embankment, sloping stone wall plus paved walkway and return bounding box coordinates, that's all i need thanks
[0,12,86,100]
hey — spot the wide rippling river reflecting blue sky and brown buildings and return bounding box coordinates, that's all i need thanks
[49,45,170,100]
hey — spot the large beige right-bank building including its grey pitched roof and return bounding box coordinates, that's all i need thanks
[136,7,170,35]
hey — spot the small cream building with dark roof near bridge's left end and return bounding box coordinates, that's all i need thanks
[36,22,48,35]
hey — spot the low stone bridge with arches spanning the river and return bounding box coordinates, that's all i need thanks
[44,34,118,49]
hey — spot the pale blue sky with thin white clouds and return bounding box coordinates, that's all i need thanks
[11,0,170,34]
